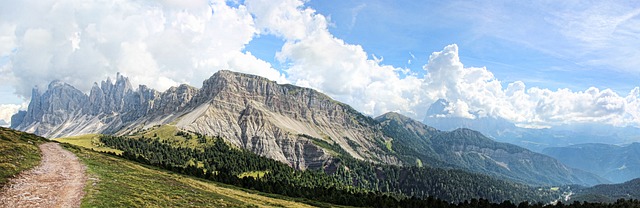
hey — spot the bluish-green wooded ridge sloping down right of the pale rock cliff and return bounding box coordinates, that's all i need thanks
[376,113,606,184]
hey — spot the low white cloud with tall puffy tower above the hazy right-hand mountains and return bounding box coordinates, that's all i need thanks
[423,45,640,126]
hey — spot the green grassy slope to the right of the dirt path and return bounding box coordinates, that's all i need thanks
[65,145,318,207]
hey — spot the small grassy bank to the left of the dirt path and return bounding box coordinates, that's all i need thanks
[0,127,47,187]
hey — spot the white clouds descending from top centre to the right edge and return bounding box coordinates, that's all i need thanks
[236,0,640,126]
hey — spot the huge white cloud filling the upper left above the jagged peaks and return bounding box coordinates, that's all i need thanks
[0,0,283,98]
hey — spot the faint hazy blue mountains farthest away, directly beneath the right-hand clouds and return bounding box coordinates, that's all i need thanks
[423,99,640,152]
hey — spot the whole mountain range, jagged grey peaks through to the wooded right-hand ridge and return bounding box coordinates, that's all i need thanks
[11,70,606,185]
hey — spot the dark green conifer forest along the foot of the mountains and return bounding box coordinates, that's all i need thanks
[100,131,640,207]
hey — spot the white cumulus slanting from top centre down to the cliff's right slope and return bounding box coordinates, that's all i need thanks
[246,0,426,117]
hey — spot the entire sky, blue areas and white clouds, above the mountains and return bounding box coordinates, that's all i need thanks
[0,0,640,128]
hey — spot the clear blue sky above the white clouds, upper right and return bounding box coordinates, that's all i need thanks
[309,0,640,93]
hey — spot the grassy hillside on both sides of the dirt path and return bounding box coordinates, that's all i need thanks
[0,127,335,207]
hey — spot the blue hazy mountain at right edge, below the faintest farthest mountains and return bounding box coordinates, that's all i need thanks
[543,143,640,183]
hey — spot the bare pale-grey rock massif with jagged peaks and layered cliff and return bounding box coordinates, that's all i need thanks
[16,70,399,169]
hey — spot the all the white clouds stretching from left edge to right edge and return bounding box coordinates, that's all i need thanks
[0,0,640,126]
